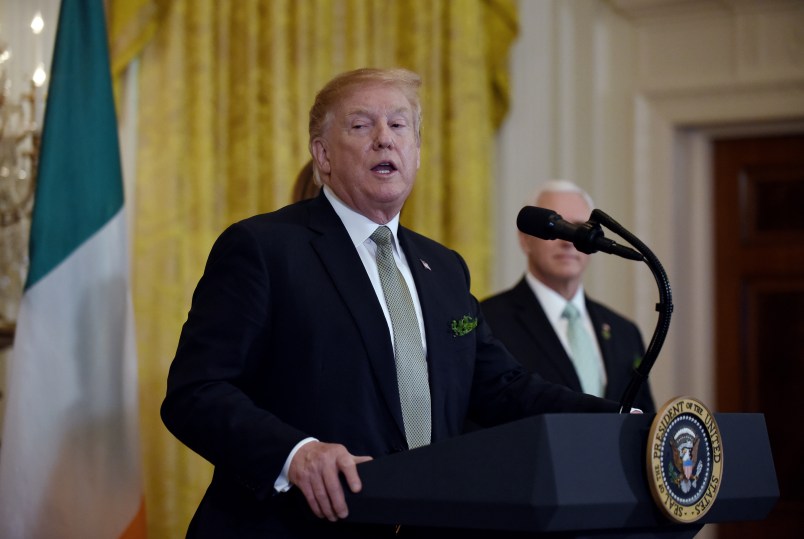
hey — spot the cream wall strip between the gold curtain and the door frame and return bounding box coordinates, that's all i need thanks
[494,0,637,304]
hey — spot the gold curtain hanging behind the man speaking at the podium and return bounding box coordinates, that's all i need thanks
[109,0,517,538]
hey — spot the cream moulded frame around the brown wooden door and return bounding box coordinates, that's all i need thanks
[633,85,804,411]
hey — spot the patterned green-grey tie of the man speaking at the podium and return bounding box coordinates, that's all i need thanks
[371,226,431,449]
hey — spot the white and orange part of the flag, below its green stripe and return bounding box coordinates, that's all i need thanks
[0,209,142,539]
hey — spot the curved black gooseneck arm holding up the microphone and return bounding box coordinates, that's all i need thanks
[589,209,673,414]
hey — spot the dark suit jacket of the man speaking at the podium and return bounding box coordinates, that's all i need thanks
[161,194,618,538]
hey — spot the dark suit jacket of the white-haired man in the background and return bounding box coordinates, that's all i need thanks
[481,278,655,412]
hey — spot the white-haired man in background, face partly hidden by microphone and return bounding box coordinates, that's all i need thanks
[481,180,655,412]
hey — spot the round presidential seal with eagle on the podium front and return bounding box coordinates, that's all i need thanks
[647,397,723,523]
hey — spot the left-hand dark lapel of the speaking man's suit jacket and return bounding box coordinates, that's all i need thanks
[310,194,404,434]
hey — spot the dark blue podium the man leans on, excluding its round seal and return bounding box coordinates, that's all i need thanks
[345,414,779,538]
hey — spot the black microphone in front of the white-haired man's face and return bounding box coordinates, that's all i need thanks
[516,206,644,261]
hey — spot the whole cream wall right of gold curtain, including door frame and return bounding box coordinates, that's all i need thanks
[493,0,804,414]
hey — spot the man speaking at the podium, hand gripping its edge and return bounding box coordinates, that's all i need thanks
[161,69,619,539]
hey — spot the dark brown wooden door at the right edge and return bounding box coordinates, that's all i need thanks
[713,134,804,539]
